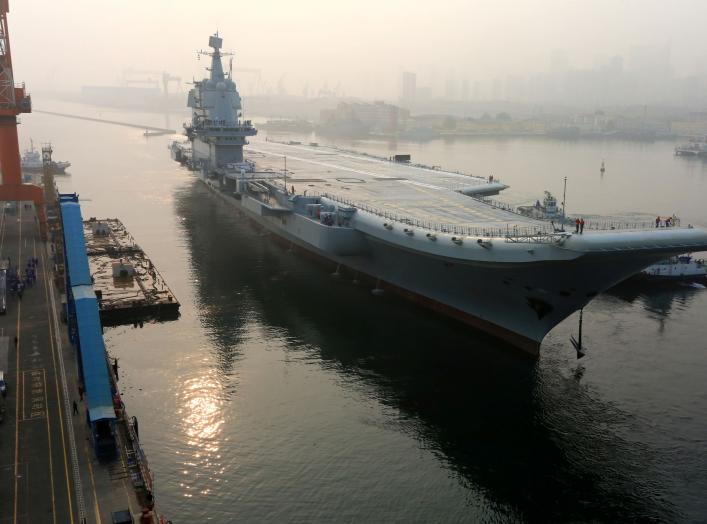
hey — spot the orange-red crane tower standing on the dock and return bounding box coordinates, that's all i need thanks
[0,0,46,236]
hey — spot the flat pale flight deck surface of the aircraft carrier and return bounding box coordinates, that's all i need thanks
[246,140,552,232]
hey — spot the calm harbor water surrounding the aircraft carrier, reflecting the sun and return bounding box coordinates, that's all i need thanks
[20,100,707,522]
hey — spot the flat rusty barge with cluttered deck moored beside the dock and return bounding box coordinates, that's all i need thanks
[83,218,179,326]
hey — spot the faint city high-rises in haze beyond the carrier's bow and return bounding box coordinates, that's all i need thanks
[398,45,707,108]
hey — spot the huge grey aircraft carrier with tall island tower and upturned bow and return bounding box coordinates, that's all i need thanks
[170,36,707,355]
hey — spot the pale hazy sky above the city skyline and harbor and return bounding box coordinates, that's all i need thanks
[9,0,707,98]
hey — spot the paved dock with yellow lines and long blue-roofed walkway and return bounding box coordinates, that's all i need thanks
[0,198,165,524]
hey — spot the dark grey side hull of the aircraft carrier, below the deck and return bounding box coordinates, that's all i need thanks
[202,179,668,356]
